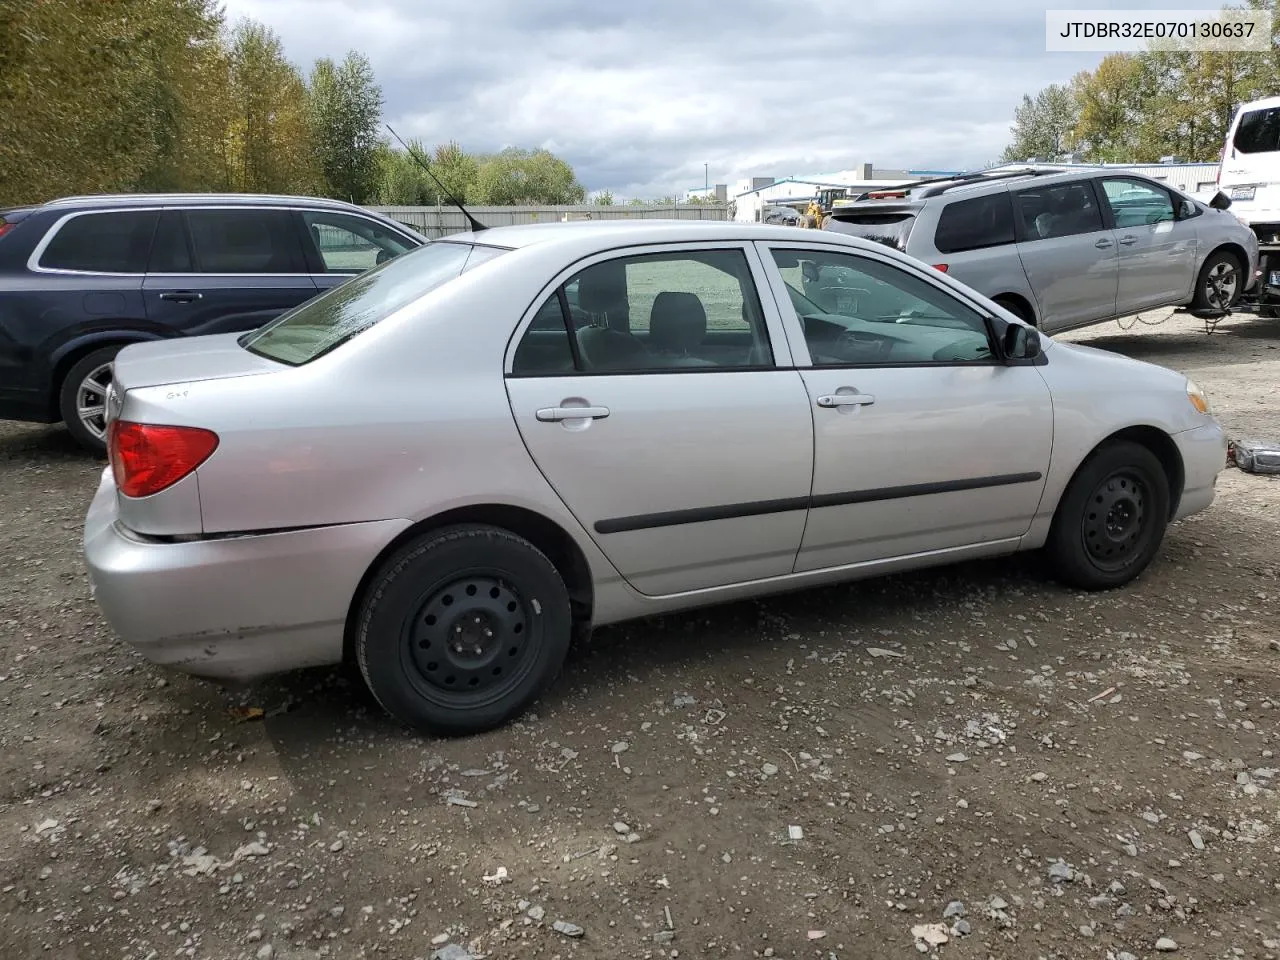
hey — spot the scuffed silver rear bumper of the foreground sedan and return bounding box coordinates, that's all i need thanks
[84,470,408,681]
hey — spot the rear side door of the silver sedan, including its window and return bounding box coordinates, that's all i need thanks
[507,243,813,595]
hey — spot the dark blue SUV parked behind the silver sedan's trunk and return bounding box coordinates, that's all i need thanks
[0,193,426,452]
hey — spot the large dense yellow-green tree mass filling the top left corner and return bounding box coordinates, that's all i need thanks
[0,0,230,202]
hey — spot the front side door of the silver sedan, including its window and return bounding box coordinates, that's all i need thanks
[762,243,1053,572]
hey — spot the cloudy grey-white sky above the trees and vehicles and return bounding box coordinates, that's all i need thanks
[224,0,1217,198]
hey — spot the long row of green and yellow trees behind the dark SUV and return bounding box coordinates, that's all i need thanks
[0,0,585,206]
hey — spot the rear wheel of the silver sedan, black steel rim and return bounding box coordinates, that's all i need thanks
[355,525,573,736]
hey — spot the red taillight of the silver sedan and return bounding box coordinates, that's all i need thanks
[106,420,218,497]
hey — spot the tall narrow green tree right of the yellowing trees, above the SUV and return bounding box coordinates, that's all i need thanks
[308,50,383,204]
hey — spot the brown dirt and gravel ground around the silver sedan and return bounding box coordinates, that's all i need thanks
[0,309,1280,960]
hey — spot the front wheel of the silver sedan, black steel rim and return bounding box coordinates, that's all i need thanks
[1047,442,1170,590]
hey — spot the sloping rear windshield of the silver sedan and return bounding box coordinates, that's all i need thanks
[239,241,506,366]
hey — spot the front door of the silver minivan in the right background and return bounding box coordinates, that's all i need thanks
[1098,177,1197,315]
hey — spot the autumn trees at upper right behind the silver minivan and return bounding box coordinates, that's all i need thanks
[1002,0,1280,163]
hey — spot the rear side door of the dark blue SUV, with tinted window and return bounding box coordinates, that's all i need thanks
[143,206,317,335]
